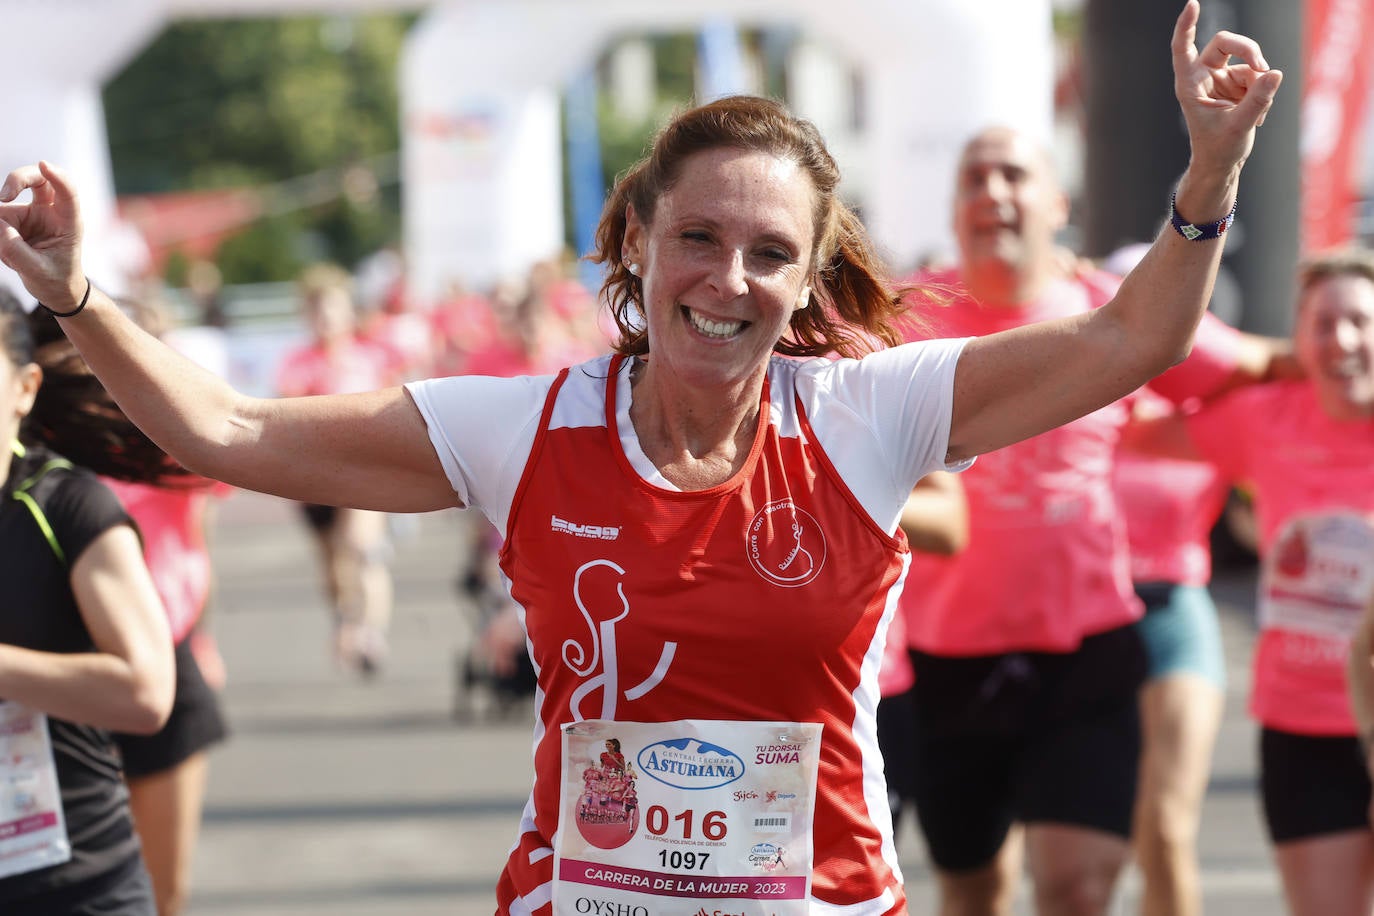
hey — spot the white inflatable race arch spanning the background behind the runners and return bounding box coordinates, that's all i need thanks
[0,0,1054,293]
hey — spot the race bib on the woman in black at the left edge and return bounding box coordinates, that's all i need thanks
[0,703,71,878]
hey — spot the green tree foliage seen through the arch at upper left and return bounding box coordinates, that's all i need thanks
[104,15,414,283]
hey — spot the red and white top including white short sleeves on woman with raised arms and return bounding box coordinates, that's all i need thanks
[409,341,962,916]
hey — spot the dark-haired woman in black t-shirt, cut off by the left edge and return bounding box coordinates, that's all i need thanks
[0,294,173,916]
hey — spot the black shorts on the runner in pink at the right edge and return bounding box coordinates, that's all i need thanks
[1260,728,1370,843]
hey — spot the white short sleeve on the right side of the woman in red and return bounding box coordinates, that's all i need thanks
[797,338,973,533]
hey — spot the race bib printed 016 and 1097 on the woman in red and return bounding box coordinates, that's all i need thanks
[554,720,822,916]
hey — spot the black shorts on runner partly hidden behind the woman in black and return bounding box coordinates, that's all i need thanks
[114,637,228,779]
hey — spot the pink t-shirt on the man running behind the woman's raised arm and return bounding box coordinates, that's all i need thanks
[903,271,1228,656]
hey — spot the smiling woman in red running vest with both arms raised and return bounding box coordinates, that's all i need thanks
[0,3,1281,915]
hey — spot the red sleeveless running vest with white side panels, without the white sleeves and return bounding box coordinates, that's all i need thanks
[497,360,907,913]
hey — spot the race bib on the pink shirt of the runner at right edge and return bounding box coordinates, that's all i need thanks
[1260,512,1374,640]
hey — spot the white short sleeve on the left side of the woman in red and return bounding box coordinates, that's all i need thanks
[405,375,554,536]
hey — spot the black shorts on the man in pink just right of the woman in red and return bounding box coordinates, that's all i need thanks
[911,626,1146,872]
